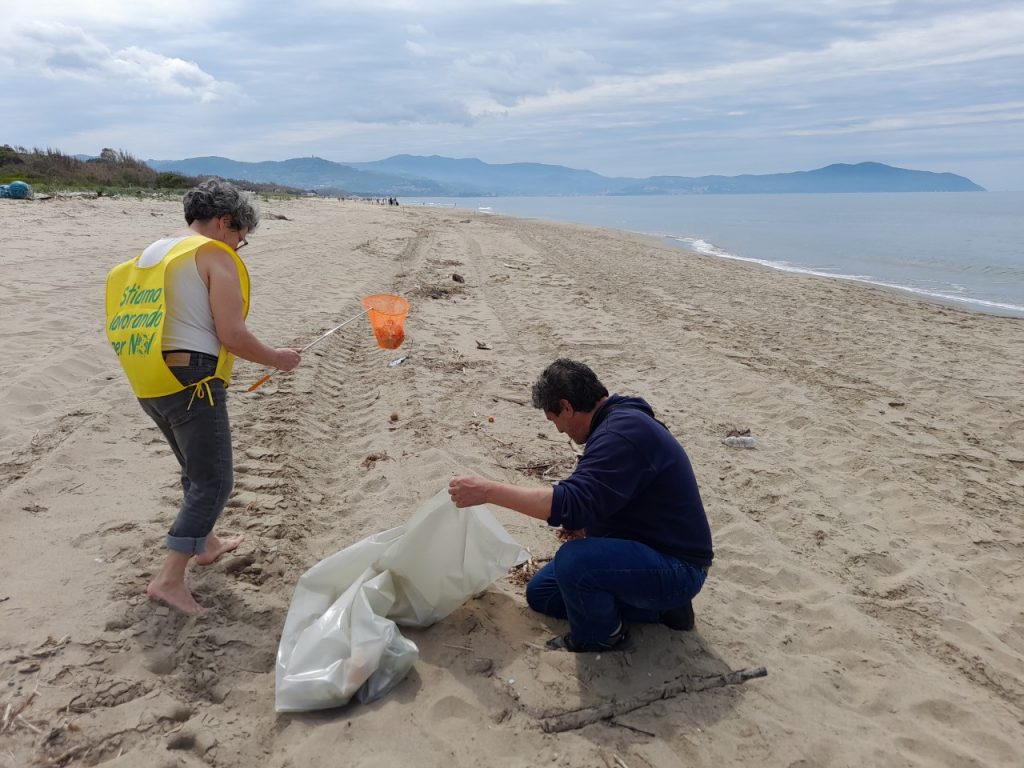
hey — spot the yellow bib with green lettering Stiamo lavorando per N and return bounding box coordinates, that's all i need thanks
[106,234,249,407]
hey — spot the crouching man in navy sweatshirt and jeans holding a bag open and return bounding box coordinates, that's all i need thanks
[449,358,714,652]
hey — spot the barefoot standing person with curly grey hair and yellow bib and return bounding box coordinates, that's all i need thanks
[106,179,299,614]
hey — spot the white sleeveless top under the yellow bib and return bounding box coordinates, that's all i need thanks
[138,238,220,356]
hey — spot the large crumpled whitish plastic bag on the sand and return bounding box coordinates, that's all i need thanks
[274,489,528,712]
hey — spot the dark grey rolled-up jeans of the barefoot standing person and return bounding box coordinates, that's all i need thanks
[139,352,234,555]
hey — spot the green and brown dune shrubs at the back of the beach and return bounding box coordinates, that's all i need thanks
[0,144,302,196]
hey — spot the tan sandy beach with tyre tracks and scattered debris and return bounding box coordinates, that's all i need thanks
[0,198,1024,768]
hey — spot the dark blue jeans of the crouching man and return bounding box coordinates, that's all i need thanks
[526,539,708,643]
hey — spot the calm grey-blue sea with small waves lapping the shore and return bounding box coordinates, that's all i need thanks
[400,191,1024,317]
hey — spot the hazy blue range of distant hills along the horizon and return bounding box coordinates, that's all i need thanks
[146,155,984,197]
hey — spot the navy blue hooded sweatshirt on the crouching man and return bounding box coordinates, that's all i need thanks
[548,394,714,566]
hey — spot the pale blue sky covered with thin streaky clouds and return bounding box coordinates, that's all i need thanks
[0,0,1024,190]
